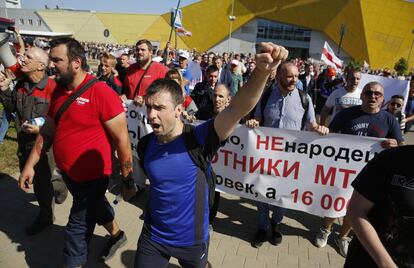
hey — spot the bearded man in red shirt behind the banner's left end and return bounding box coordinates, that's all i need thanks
[122,39,168,106]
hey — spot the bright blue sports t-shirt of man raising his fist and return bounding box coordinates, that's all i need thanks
[144,120,220,247]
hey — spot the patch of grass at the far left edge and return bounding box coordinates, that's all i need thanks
[0,104,19,175]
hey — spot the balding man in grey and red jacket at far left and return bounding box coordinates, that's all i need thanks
[0,47,64,235]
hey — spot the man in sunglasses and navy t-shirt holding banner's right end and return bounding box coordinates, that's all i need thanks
[315,82,404,257]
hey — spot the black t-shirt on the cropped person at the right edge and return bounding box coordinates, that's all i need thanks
[345,145,414,267]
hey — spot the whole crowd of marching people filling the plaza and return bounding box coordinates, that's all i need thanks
[0,33,414,267]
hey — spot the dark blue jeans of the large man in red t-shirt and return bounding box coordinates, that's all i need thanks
[62,173,115,267]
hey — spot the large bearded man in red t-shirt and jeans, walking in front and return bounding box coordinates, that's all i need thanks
[19,38,135,267]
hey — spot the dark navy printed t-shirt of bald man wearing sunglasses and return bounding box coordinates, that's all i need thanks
[329,105,404,142]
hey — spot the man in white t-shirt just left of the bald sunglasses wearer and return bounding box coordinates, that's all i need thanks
[320,69,362,126]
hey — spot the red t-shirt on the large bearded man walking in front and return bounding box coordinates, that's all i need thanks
[49,74,124,181]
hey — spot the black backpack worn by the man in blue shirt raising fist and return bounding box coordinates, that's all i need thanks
[137,124,217,208]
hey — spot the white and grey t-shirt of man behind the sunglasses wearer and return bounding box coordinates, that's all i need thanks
[325,87,362,120]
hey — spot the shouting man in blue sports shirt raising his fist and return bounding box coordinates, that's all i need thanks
[135,43,288,268]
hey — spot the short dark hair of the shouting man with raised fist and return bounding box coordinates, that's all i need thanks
[146,78,184,106]
